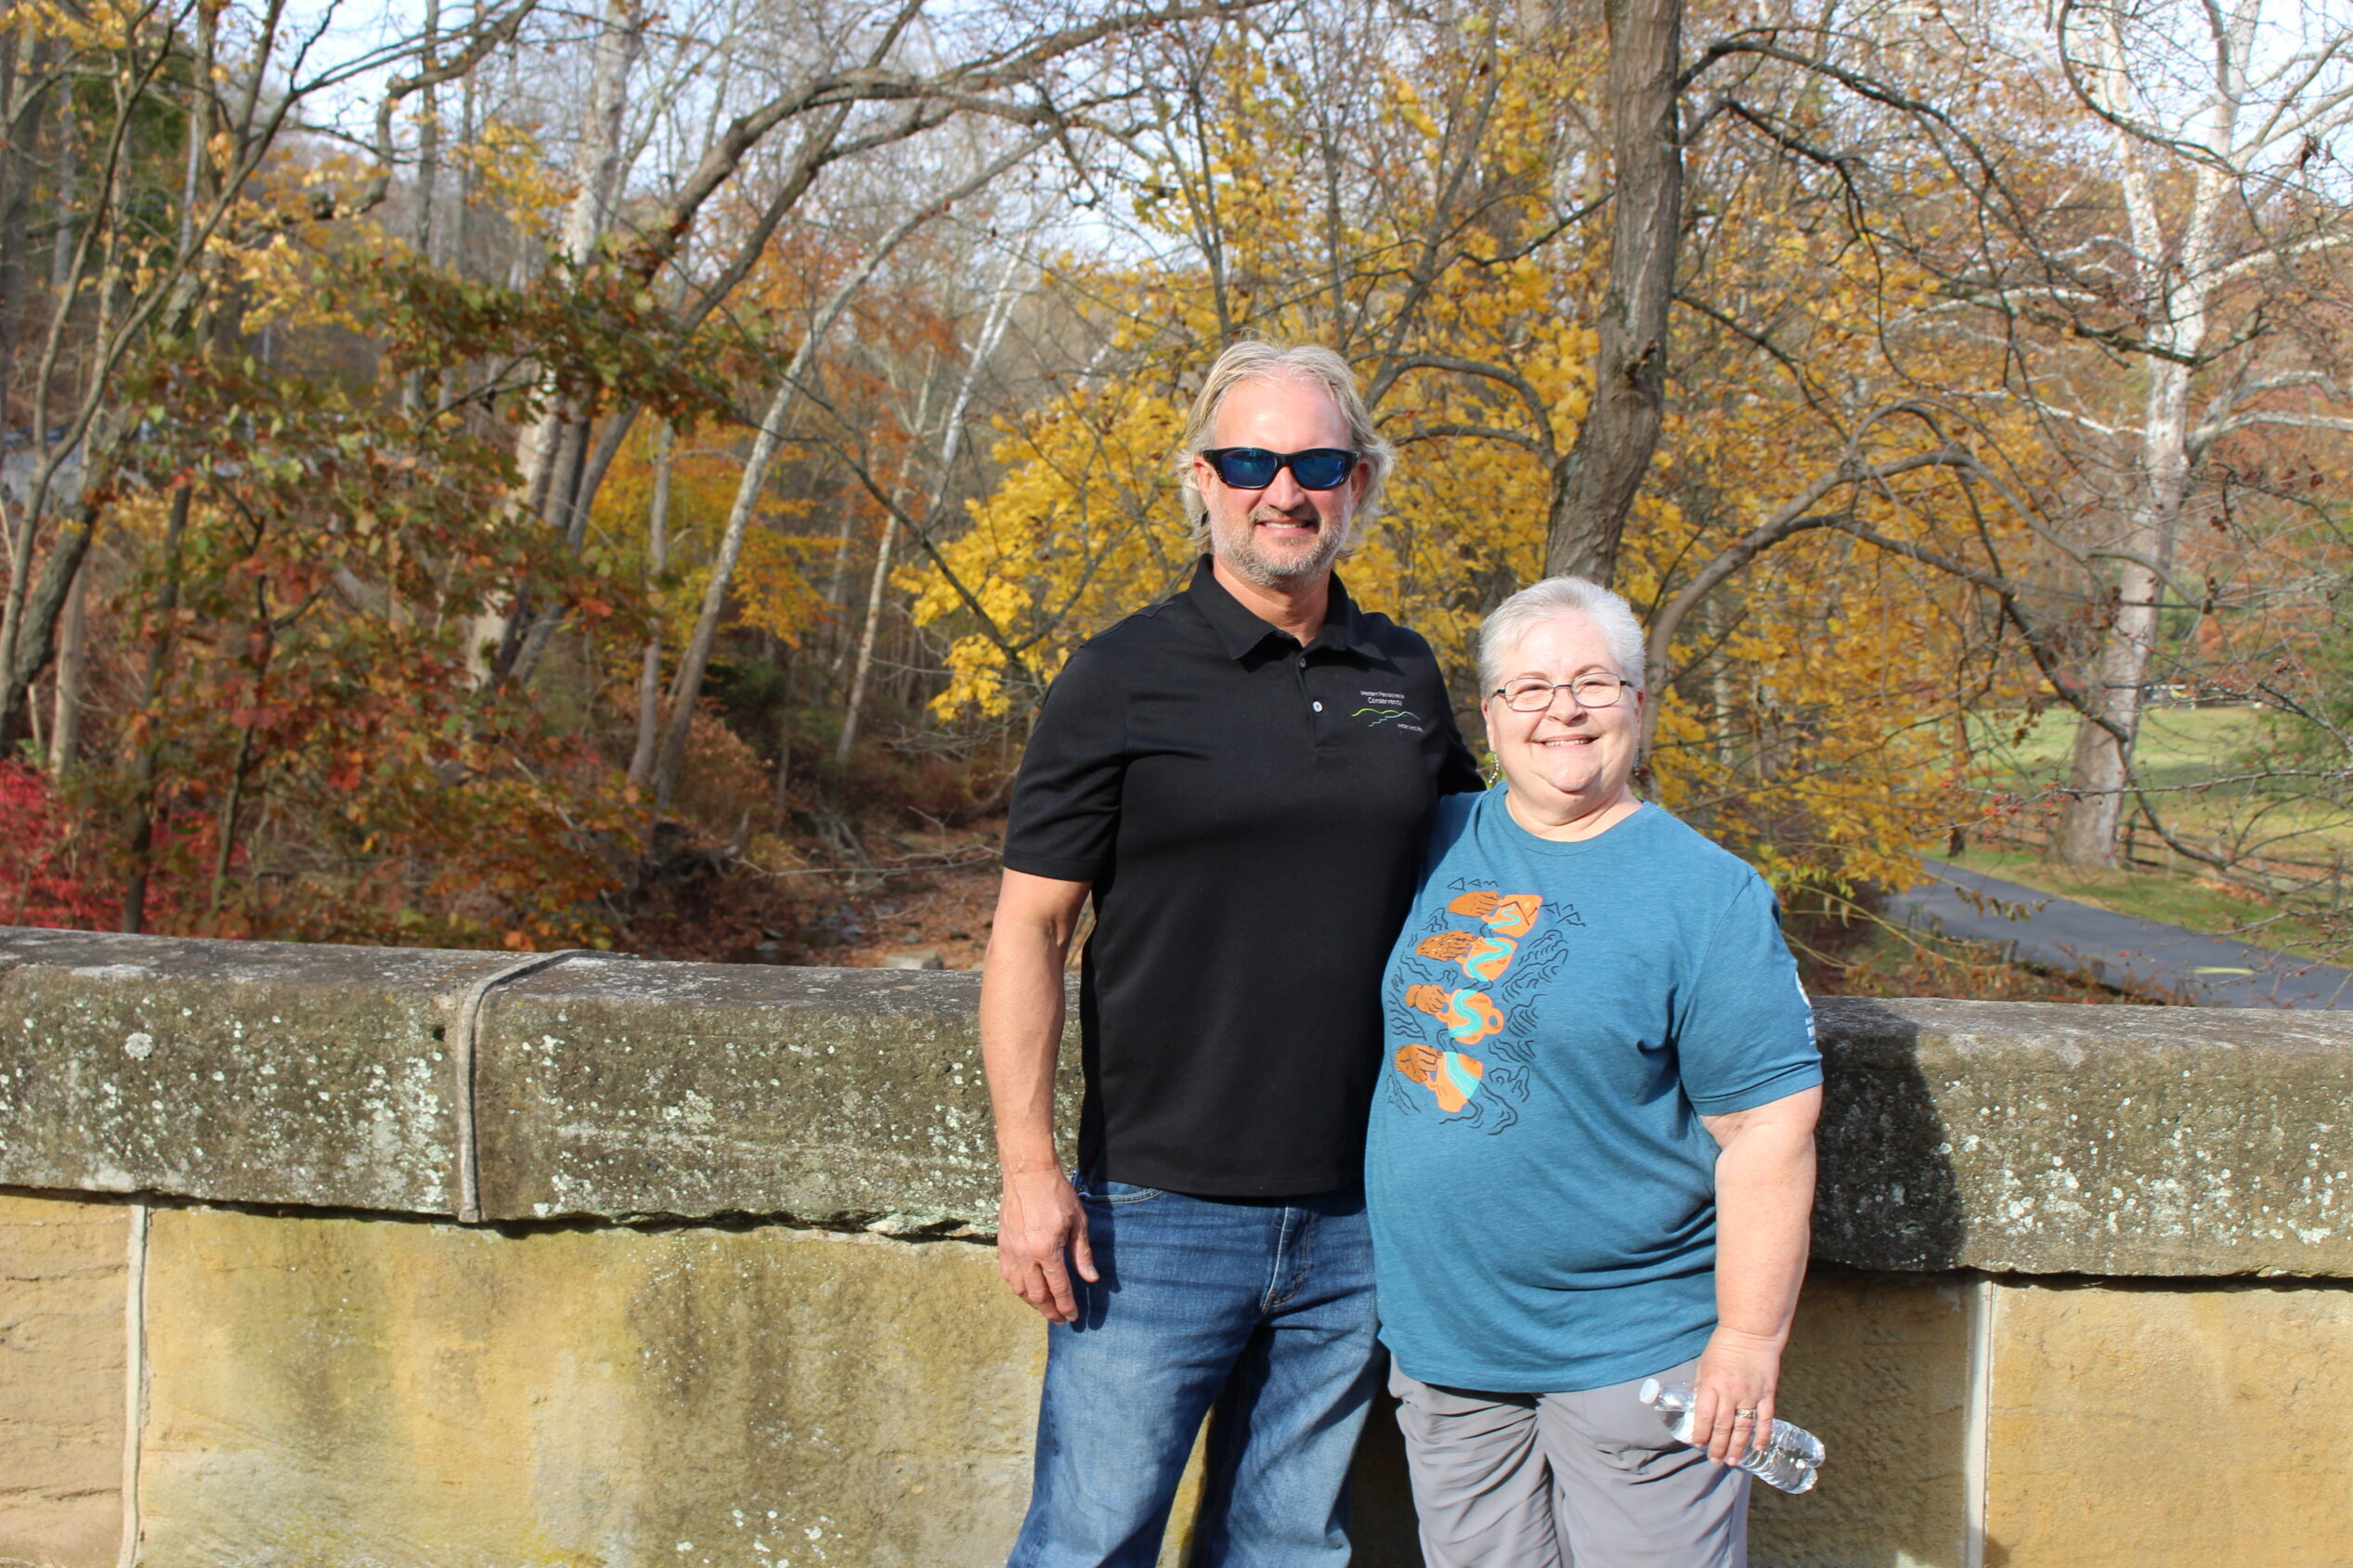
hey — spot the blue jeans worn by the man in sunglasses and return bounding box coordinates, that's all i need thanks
[1009,1183,1379,1568]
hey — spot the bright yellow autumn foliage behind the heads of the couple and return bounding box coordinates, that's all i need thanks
[911,24,2031,887]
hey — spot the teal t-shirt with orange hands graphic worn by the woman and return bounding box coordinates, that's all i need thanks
[1365,785,1821,1394]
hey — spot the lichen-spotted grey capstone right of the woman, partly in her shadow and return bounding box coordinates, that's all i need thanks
[1814,997,2353,1276]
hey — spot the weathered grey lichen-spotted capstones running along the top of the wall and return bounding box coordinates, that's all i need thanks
[0,931,2353,1276]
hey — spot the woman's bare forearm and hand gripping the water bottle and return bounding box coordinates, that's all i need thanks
[1692,1088,1821,1462]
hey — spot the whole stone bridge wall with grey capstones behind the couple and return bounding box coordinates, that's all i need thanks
[0,928,2353,1568]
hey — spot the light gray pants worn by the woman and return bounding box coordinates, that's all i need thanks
[1388,1361,1748,1568]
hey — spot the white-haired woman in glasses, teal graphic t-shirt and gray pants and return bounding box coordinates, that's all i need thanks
[1365,578,1821,1568]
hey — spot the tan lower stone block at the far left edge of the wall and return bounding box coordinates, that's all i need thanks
[0,1192,129,1568]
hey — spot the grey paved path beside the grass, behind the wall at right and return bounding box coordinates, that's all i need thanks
[1887,861,2353,1008]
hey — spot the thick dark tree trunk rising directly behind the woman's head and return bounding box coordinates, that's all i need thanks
[1543,0,1683,583]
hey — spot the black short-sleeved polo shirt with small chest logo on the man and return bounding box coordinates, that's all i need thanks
[1005,560,1480,1197]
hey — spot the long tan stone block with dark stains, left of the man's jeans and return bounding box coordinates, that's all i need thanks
[141,1209,1045,1568]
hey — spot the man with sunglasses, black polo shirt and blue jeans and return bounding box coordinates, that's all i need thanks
[982,343,1480,1568]
